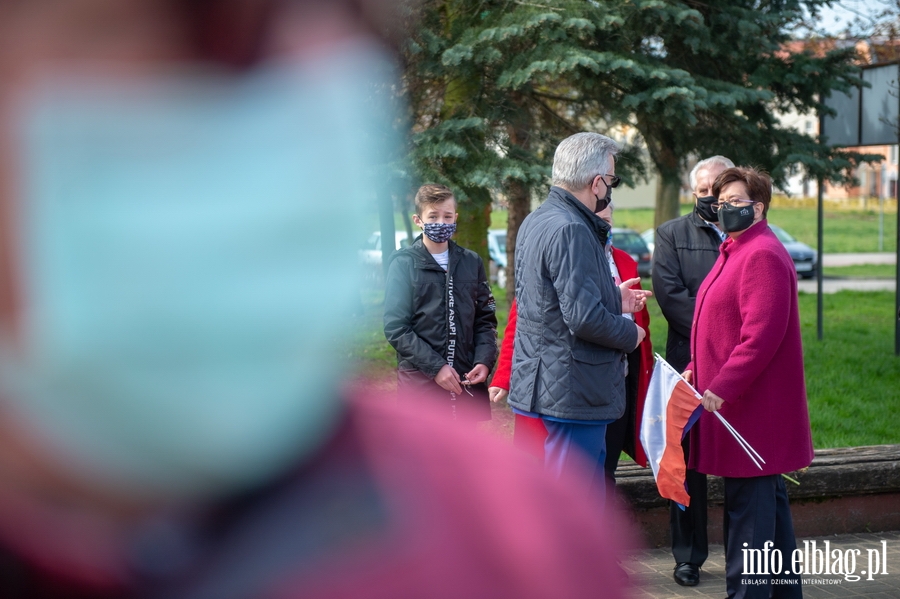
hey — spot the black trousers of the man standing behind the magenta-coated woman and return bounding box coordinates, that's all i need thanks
[669,434,709,566]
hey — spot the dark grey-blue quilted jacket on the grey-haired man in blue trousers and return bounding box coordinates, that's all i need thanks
[509,187,637,420]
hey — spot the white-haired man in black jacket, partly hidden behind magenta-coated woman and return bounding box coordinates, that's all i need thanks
[653,156,734,586]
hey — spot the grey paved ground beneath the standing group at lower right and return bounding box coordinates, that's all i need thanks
[624,532,900,599]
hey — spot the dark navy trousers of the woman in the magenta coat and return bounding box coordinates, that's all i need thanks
[722,474,803,599]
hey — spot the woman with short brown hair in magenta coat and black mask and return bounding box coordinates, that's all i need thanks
[685,168,813,598]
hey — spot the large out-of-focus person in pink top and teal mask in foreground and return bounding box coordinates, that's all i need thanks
[0,0,636,599]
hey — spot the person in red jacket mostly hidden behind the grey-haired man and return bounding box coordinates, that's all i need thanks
[489,204,653,492]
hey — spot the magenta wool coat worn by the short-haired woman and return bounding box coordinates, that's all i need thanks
[688,220,813,478]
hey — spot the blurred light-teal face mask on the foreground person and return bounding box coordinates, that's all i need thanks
[0,47,391,498]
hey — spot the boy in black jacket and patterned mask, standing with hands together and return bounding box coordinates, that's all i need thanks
[384,184,498,420]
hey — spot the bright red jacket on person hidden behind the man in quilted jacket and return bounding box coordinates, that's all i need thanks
[491,247,653,468]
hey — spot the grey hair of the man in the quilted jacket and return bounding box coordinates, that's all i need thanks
[552,132,619,191]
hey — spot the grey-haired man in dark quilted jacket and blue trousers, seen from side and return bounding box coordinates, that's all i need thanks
[509,133,648,502]
